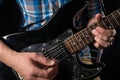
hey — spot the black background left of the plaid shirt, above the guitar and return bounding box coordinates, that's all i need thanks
[0,0,21,36]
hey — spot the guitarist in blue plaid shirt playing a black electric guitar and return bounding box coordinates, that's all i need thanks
[0,0,116,80]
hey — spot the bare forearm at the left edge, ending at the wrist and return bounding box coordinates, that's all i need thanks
[0,40,17,66]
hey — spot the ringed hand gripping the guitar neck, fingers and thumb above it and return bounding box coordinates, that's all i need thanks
[88,14,116,49]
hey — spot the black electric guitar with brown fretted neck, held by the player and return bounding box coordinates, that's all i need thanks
[3,0,120,80]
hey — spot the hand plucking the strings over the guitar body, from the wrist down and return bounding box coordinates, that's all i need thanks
[13,52,58,80]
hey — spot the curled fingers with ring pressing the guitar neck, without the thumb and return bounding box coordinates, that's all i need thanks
[92,27,116,49]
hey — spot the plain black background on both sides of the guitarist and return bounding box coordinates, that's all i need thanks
[0,0,120,80]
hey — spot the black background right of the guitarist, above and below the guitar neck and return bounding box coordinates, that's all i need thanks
[101,0,120,80]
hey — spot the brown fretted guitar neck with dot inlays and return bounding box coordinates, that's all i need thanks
[64,9,120,53]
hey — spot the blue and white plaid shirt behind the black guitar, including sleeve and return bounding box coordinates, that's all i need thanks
[17,0,101,57]
